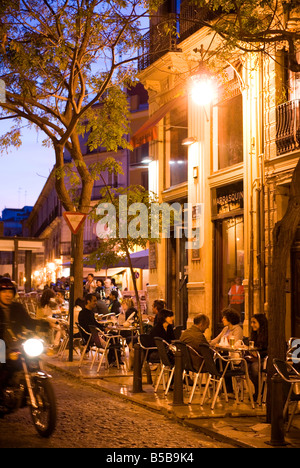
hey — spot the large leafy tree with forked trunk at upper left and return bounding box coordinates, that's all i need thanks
[0,0,161,297]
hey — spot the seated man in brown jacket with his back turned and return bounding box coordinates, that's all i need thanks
[180,314,210,369]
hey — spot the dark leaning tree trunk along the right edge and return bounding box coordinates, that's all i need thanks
[267,159,300,422]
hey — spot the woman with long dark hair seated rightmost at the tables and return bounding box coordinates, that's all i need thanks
[246,314,268,401]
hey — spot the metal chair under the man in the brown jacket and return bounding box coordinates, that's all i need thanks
[173,340,204,404]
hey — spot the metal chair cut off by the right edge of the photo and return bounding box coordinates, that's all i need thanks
[273,358,300,432]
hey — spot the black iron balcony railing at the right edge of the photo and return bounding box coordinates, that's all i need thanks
[276,99,300,154]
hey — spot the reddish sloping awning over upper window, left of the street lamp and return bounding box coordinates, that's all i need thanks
[130,96,183,148]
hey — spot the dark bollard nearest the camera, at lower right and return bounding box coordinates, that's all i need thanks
[267,374,287,447]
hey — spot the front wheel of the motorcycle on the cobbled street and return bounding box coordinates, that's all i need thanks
[30,379,56,437]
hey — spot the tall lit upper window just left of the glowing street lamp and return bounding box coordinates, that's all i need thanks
[164,99,188,187]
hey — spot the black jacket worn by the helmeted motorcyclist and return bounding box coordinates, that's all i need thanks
[0,302,49,340]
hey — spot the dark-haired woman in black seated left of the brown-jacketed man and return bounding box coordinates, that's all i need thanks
[148,309,175,362]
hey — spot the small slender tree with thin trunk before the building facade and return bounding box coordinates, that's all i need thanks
[89,158,160,333]
